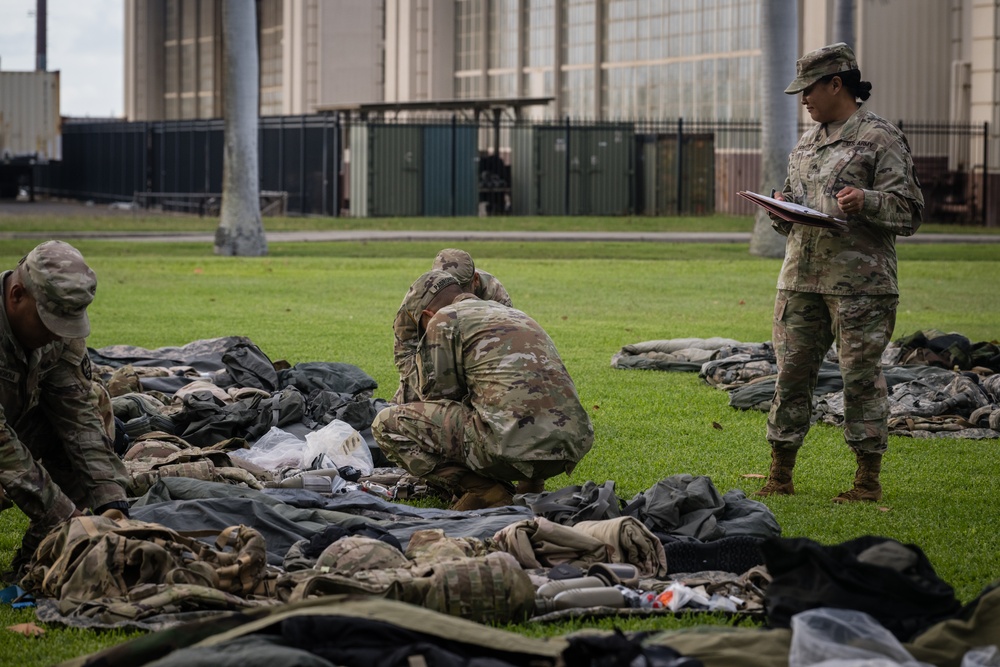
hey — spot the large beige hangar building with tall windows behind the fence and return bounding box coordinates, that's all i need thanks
[125,0,1000,132]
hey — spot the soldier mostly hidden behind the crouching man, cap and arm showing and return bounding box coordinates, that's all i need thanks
[392,248,514,403]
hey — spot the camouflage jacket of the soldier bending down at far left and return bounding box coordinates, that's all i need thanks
[0,271,126,524]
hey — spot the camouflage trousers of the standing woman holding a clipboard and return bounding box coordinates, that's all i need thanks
[767,290,899,453]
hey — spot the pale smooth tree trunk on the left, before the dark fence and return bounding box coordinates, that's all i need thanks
[215,0,267,257]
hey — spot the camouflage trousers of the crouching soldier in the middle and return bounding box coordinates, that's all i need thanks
[372,400,552,492]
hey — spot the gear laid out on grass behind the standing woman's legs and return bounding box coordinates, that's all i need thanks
[611,329,1000,439]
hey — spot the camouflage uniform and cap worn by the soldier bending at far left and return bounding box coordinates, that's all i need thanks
[0,242,128,566]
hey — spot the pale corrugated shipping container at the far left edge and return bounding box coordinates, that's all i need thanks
[0,72,62,160]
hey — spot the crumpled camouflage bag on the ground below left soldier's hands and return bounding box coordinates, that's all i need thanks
[21,516,267,615]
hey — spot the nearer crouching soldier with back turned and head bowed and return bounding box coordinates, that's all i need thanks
[372,271,594,510]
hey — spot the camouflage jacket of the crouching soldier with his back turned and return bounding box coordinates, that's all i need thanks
[417,295,594,470]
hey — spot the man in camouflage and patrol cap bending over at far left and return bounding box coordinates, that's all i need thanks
[0,241,129,583]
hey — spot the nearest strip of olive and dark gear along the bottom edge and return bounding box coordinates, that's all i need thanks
[56,582,1000,667]
